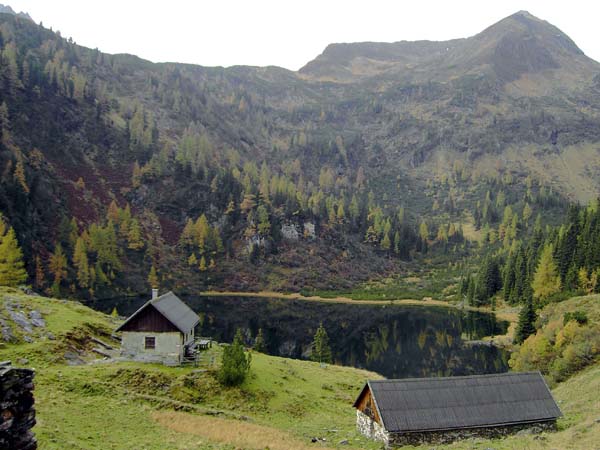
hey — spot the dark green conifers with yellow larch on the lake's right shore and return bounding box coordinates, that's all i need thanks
[459,200,600,342]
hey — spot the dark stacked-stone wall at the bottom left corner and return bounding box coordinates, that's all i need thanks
[0,361,37,450]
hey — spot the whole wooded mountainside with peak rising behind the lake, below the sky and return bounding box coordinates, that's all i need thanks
[0,12,600,296]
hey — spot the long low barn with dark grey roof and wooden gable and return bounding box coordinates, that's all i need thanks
[354,372,562,446]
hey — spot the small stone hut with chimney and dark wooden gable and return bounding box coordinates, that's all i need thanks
[116,289,199,365]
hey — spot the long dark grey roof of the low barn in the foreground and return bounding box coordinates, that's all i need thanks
[354,372,562,432]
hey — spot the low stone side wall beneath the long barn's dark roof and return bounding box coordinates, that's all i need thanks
[386,421,556,447]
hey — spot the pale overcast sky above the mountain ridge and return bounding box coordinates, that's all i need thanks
[8,0,600,70]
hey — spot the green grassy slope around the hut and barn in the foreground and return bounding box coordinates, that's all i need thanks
[0,288,600,449]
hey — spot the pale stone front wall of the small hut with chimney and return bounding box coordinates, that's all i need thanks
[121,331,183,365]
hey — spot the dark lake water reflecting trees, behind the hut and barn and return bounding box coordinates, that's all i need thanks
[92,297,508,378]
